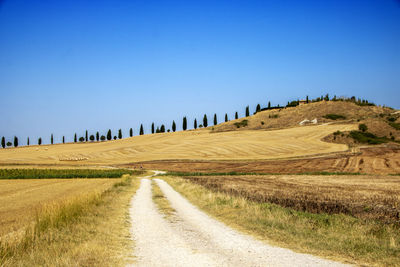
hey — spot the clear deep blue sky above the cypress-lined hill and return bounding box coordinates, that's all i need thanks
[0,0,400,144]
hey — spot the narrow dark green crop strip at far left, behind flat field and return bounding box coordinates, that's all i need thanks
[0,169,143,179]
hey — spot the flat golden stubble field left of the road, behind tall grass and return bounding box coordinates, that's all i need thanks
[0,179,116,236]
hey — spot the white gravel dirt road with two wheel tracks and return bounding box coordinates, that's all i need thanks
[130,177,343,266]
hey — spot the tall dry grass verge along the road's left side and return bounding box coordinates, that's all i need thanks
[0,176,144,266]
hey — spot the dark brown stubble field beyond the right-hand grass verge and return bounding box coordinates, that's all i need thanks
[185,175,400,226]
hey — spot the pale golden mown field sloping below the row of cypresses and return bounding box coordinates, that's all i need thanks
[0,124,357,165]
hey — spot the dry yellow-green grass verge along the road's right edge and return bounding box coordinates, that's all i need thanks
[163,176,400,266]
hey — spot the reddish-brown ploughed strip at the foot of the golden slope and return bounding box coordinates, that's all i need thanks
[128,145,400,174]
